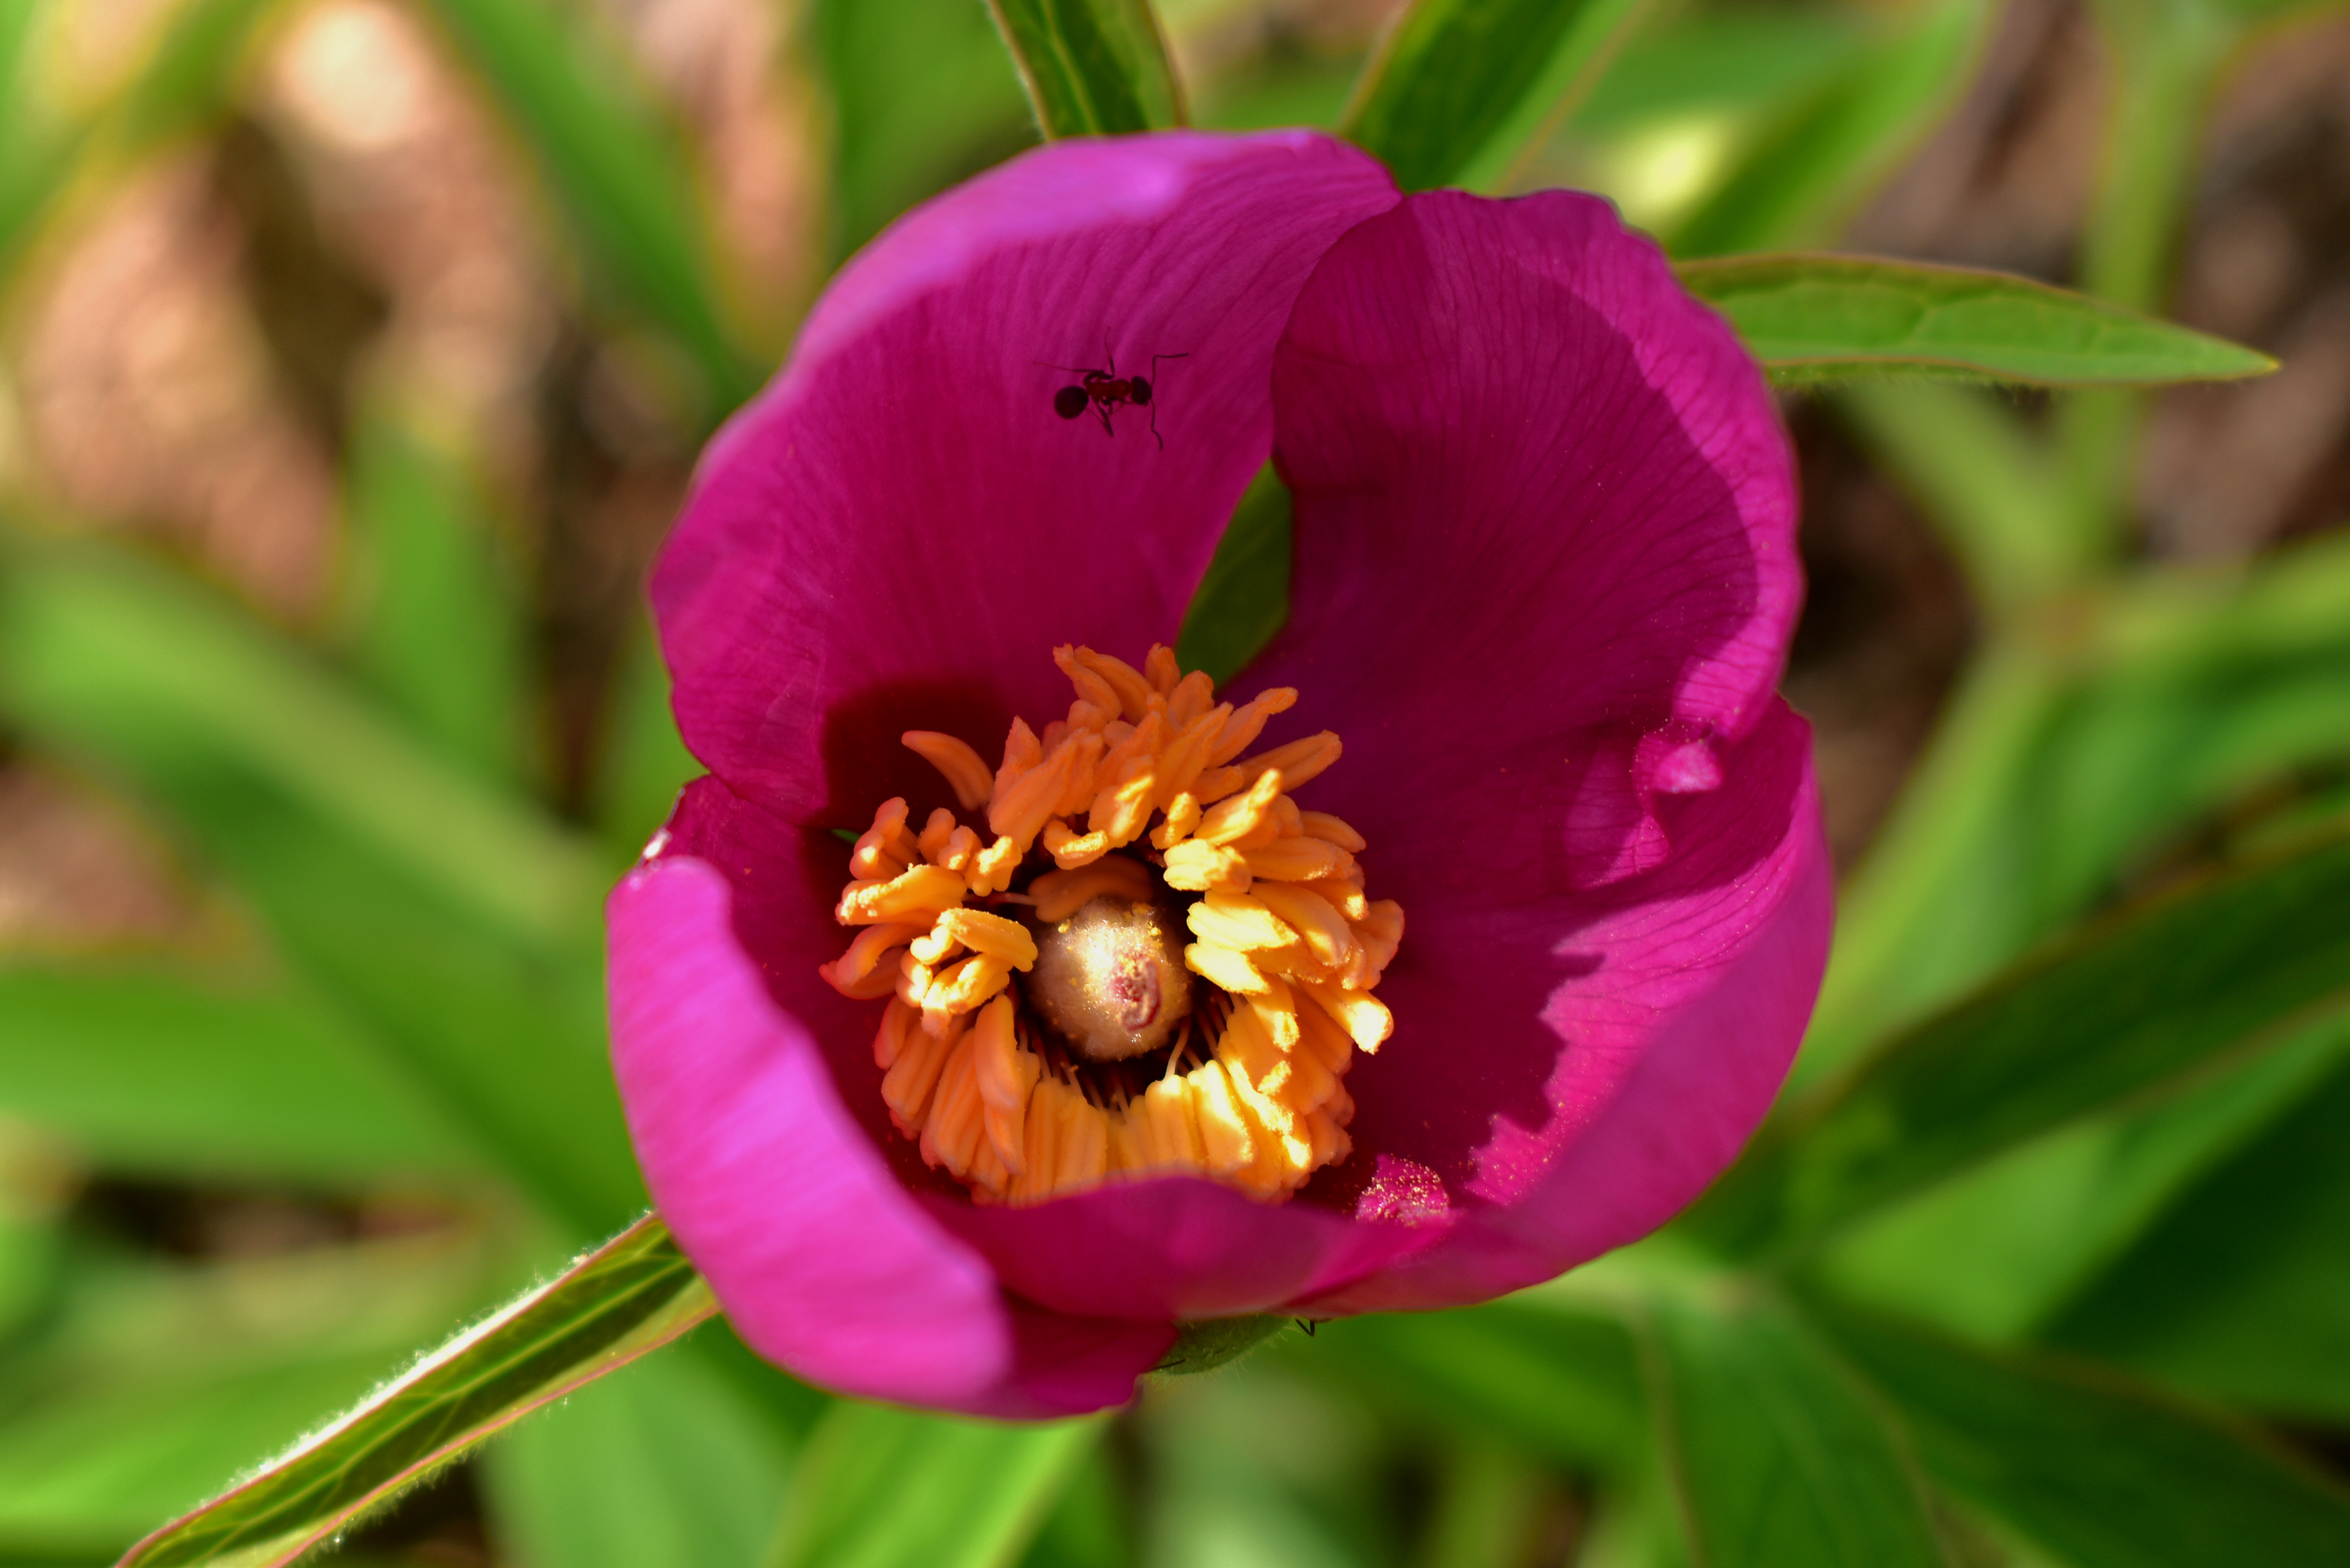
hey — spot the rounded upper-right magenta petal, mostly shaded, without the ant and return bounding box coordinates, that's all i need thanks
[1274,190,1802,752]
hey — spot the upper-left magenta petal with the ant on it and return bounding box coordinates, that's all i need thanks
[653,132,1396,827]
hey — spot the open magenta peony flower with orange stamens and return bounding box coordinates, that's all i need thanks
[608,132,1830,1417]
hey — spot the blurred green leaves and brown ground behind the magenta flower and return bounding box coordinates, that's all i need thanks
[0,0,2350,1568]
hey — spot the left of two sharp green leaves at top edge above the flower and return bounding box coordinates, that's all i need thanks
[987,0,1184,139]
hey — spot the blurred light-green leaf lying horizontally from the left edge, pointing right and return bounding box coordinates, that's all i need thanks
[0,964,484,1182]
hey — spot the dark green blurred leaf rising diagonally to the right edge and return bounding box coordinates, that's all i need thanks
[1692,827,2350,1255]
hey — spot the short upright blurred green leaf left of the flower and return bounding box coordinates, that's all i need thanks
[343,411,526,783]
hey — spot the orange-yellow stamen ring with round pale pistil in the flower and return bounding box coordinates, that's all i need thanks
[820,647,1403,1204]
